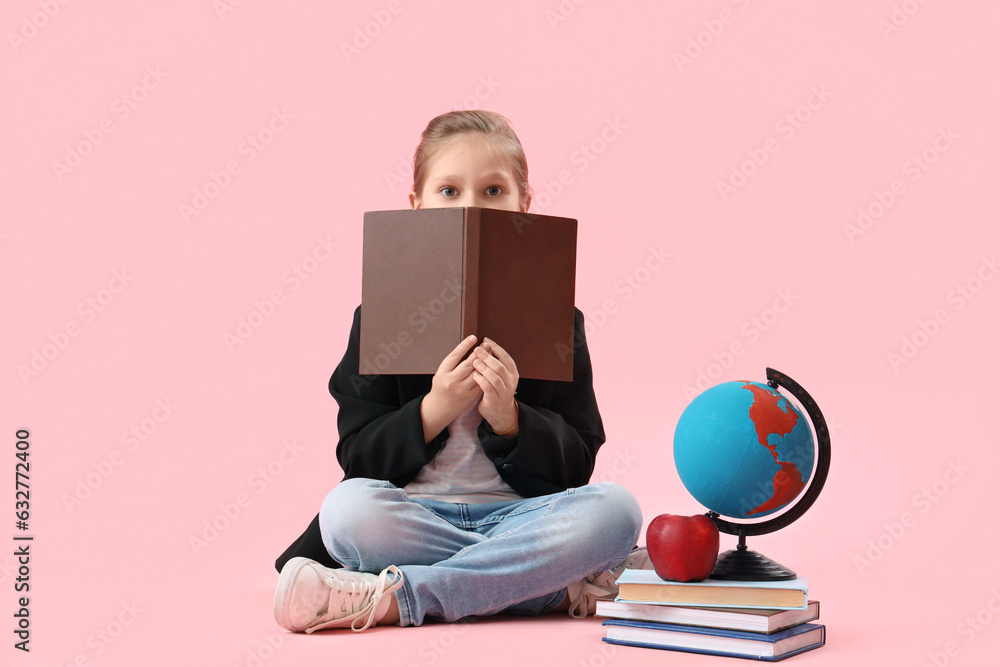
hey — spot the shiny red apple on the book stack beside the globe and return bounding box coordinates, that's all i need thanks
[646,514,719,581]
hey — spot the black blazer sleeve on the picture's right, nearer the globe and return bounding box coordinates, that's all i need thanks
[479,309,605,497]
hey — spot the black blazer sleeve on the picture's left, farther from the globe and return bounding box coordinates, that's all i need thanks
[330,306,448,486]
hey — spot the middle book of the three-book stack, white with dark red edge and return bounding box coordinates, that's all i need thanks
[597,600,820,634]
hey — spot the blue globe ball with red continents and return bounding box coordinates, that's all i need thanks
[674,381,825,519]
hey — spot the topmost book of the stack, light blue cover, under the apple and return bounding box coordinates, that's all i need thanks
[617,570,809,609]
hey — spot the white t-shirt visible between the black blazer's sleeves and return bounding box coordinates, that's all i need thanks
[403,394,521,504]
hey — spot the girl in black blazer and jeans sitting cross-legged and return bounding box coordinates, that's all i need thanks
[274,111,646,633]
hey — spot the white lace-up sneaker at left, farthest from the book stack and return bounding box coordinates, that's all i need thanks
[274,558,403,634]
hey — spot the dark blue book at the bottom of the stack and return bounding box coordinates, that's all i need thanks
[603,619,826,662]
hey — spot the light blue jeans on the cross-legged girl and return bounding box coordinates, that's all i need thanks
[320,478,642,626]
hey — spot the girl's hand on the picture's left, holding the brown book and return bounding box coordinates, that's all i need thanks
[420,336,480,442]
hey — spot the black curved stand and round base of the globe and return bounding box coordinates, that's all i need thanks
[707,368,830,581]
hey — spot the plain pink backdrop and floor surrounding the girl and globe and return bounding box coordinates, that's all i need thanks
[0,0,1000,667]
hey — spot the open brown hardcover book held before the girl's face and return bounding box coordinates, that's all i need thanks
[359,206,577,381]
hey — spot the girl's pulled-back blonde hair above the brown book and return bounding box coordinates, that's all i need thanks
[413,109,531,208]
